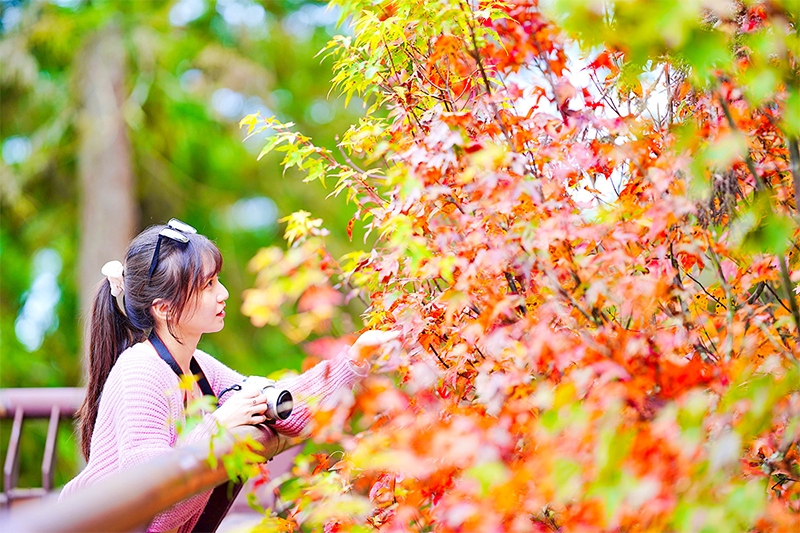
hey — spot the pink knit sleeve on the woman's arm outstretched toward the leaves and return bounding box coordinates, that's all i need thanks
[274,353,367,437]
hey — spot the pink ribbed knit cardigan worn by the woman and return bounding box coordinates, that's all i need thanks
[60,342,360,533]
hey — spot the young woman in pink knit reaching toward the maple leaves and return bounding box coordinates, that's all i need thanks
[61,219,367,532]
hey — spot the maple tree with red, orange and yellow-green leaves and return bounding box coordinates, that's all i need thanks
[242,0,800,531]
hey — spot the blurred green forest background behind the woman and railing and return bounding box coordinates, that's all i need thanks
[0,0,362,486]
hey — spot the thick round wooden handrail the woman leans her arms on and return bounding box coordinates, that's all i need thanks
[0,389,298,532]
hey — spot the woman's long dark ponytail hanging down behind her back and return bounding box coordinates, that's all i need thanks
[78,279,144,461]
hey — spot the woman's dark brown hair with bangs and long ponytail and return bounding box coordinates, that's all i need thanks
[78,225,222,461]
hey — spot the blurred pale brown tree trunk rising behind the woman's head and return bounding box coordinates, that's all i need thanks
[76,24,137,364]
